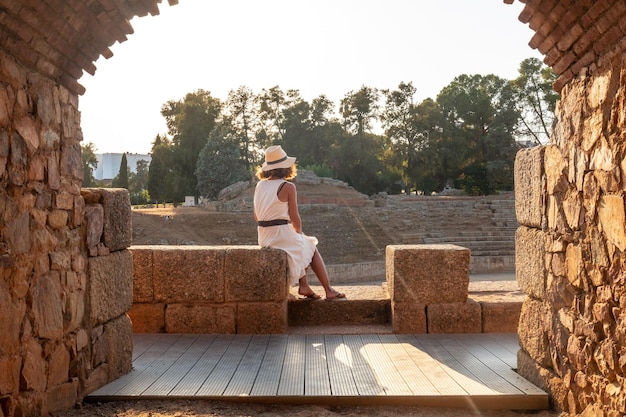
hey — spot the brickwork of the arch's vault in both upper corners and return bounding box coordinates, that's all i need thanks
[0,0,626,94]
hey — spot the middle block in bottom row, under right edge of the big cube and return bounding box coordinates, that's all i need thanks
[426,300,482,334]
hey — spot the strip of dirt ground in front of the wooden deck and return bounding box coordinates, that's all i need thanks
[53,400,564,417]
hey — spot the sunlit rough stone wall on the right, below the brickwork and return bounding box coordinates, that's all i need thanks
[515,46,626,416]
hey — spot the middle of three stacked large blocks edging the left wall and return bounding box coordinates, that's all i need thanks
[88,250,133,325]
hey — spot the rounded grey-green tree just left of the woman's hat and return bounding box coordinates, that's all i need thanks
[196,124,250,200]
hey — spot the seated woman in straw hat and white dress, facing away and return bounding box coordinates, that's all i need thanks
[254,145,346,300]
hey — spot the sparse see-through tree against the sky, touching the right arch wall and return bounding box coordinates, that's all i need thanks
[511,58,559,145]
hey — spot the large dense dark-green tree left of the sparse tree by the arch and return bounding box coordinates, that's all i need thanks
[437,74,520,194]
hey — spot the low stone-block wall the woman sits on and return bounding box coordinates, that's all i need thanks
[128,246,288,334]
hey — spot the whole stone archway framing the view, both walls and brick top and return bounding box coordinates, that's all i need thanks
[0,0,626,416]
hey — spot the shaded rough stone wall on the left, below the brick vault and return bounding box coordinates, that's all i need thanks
[0,51,132,416]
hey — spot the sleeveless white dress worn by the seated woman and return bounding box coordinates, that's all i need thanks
[254,180,317,285]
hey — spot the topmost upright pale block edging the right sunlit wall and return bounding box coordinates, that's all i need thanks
[514,146,545,227]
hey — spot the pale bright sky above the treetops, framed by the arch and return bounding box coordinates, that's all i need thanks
[79,0,543,154]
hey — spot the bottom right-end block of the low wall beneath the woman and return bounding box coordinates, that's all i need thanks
[236,298,289,334]
